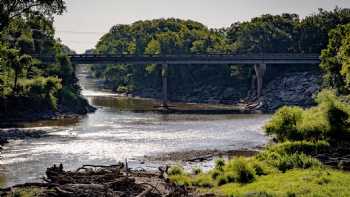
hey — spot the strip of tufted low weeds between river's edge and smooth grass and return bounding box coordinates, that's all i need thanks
[169,153,322,193]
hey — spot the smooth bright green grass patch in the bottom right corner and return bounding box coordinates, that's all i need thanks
[216,168,350,197]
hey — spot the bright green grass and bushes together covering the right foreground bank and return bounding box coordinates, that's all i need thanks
[170,90,350,197]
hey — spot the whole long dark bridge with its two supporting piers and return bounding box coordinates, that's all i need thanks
[38,53,320,107]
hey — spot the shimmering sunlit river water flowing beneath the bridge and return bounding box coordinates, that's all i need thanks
[0,67,270,186]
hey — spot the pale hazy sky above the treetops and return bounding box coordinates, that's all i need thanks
[54,0,350,53]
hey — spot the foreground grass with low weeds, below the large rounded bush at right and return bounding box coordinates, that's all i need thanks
[170,150,350,197]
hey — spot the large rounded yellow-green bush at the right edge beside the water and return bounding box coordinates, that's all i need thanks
[265,90,350,142]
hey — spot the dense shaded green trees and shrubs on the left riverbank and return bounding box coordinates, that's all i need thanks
[0,8,88,119]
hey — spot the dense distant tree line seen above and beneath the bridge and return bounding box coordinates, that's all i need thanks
[92,8,350,99]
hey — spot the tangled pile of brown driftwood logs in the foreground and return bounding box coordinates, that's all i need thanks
[0,163,188,197]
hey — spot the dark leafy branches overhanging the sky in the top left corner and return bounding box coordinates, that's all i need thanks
[0,0,66,31]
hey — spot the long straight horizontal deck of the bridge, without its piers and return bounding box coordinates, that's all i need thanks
[34,54,320,64]
